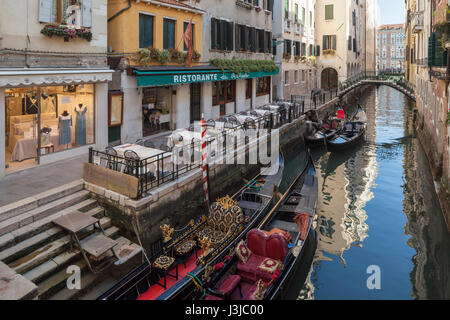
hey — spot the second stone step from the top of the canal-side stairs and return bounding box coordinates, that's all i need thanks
[0,190,89,236]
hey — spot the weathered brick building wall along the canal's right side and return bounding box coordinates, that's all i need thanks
[405,0,450,185]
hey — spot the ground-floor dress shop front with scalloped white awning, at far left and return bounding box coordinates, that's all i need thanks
[0,70,111,177]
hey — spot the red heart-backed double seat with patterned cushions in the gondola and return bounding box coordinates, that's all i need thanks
[237,229,288,282]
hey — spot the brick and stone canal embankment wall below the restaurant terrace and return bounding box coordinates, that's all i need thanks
[85,87,365,248]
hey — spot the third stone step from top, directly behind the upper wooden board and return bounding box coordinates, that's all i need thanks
[0,199,98,250]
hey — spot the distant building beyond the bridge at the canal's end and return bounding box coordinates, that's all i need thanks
[377,24,405,73]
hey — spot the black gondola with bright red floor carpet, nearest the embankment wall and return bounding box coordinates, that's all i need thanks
[97,154,284,300]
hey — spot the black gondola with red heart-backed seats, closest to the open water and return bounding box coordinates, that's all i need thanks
[183,151,318,300]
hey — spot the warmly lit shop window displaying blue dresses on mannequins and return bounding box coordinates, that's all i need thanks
[5,84,95,169]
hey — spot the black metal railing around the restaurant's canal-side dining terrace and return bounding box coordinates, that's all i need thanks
[88,102,303,199]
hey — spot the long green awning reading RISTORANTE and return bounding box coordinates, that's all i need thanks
[133,69,278,87]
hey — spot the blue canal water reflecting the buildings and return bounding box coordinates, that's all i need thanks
[280,86,450,300]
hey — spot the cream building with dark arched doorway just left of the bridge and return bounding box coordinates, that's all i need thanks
[315,0,370,90]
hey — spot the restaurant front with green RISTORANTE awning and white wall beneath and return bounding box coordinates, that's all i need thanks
[132,66,278,132]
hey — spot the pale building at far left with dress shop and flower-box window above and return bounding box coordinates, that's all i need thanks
[0,0,112,177]
